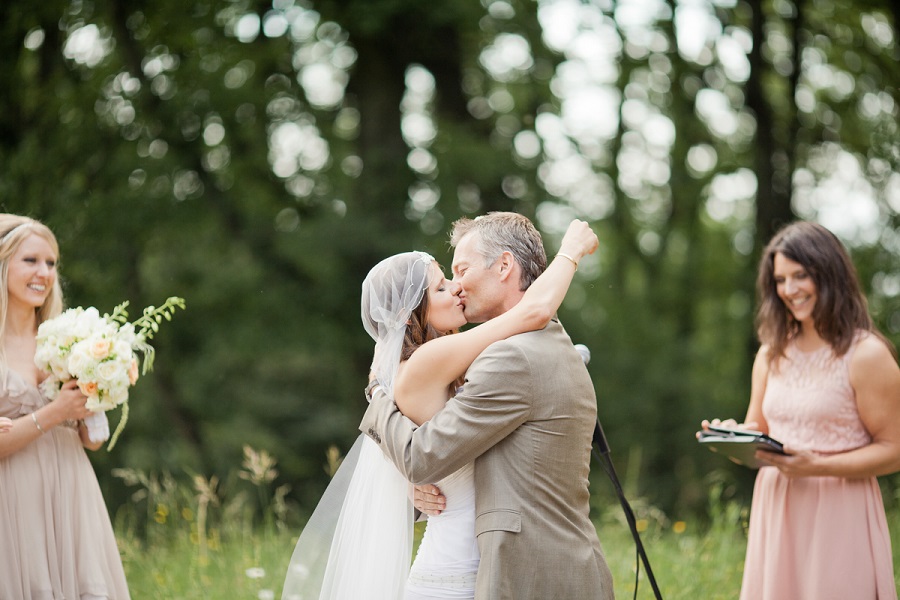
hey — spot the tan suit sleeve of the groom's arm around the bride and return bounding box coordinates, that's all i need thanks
[359,338,533,484]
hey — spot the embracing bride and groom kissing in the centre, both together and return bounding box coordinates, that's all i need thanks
[282,212,614,600]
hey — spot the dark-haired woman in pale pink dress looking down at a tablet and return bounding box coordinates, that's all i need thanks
[703,222,900,600]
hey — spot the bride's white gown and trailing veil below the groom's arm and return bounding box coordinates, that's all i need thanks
[282,435,478,600]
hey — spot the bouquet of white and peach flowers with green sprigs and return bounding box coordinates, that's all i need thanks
[34,296,184,450]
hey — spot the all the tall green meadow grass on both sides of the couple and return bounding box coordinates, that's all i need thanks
[115,448,900,600]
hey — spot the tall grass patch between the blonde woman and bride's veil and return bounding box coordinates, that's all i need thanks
[114,447,298,600]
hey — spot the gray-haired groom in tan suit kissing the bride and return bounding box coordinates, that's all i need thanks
[359,212,613,600]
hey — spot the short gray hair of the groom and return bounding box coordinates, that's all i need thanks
[450,212,547,291]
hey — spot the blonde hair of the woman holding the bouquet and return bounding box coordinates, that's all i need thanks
[0,213,63,368]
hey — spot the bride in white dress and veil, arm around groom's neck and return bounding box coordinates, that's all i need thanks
[282,220,598,600]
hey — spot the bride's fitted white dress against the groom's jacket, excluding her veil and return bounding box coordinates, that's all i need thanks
[405,463,479,600]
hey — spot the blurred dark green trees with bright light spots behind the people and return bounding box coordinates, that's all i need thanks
[0,0,900,513]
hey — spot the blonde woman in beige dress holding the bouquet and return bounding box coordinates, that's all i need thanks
[0,214,129,600]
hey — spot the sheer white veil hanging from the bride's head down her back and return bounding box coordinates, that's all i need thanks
[281,252,434,600]
